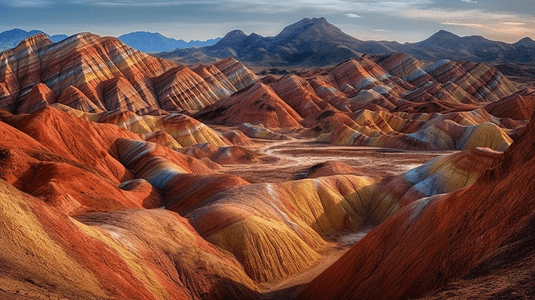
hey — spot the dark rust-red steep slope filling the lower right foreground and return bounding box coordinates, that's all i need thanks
[301,106,535,299]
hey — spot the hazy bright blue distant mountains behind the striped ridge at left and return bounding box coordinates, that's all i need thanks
[0,28,221,52]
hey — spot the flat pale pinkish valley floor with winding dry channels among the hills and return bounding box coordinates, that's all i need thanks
[221,137,448,183]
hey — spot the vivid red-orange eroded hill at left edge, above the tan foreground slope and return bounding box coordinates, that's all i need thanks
[0,108,218,215]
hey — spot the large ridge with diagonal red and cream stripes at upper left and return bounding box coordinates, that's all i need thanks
[0,33,258,114]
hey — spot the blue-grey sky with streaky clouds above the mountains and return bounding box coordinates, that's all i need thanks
[0,0,535,43]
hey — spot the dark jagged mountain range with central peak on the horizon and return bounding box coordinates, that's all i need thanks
[158,18,535,67]
